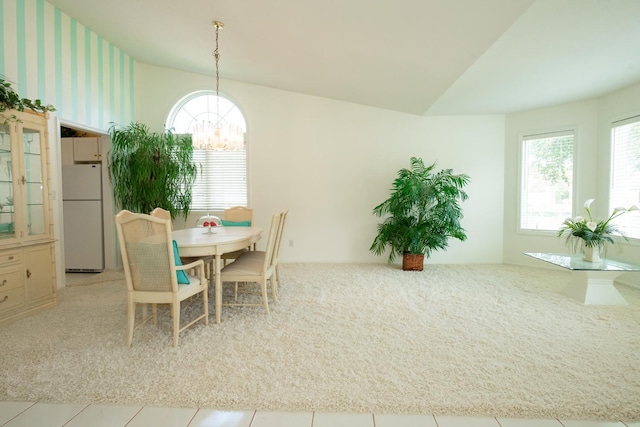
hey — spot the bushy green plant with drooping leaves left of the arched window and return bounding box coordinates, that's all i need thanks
[109,123,197,218]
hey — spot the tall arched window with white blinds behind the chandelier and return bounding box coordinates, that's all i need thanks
[167,91,248,212]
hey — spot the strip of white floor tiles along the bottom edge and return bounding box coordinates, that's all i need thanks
[0,402,640,427]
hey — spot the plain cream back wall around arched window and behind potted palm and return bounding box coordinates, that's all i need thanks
[136,64,505,263]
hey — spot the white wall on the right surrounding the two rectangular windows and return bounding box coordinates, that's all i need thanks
[504,84,640,284]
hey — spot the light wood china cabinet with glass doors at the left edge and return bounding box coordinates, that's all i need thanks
[0,111,57,324]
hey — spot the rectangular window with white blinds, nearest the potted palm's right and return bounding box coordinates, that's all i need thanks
[520,131,574,231]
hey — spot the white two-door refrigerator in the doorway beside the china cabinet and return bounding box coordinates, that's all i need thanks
[62,164,104,272]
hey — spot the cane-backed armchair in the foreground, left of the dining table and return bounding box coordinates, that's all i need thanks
[115,210,209,347]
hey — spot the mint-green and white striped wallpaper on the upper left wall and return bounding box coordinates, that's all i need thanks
[0,0,135,131]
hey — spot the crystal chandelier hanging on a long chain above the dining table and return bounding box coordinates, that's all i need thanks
[191,21,244,151]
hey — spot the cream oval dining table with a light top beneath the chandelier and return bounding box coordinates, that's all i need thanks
[172,226,262,324]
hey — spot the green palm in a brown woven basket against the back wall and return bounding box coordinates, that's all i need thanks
[370,157,470,271]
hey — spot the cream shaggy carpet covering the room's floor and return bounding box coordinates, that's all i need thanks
[0,264,640,421]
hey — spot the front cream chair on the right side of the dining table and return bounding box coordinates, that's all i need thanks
[220,214,280,314]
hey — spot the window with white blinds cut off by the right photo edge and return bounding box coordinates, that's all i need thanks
[609,116,640,239]
